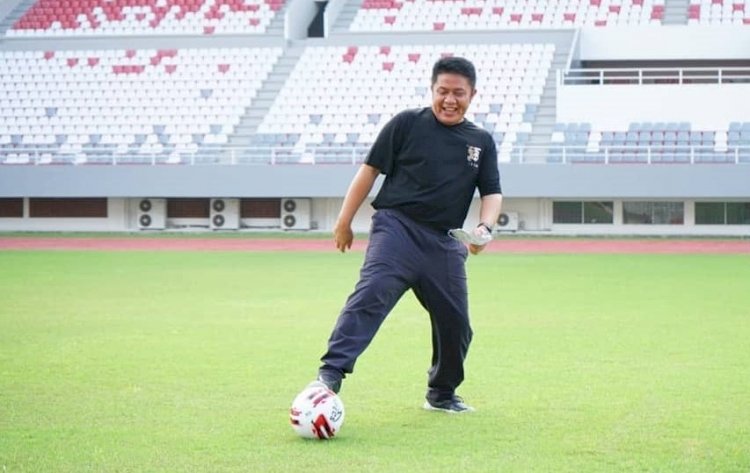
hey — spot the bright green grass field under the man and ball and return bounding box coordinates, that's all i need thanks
[0,251,750,473]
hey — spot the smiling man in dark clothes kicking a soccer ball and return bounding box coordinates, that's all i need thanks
[314,57,502,413]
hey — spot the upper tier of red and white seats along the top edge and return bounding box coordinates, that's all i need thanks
[6,0,750,37]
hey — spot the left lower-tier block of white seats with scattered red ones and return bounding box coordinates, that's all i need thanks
[0,48,281,164]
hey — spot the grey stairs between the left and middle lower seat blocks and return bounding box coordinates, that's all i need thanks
[229,43,305,147]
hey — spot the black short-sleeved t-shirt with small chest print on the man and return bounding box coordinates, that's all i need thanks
[365,107,501,231]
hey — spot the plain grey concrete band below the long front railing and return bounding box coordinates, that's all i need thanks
[0,163,750,199]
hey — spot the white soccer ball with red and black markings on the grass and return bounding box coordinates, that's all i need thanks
[289,383,344,440]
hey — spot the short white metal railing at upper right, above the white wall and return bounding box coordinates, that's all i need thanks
[557,67,750,85]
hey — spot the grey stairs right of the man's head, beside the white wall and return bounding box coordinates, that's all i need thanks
[524,45,572,162]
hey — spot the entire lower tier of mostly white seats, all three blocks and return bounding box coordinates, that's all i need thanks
[0,43,750,166]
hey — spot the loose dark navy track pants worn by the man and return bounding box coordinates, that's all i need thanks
[321,209,472,401]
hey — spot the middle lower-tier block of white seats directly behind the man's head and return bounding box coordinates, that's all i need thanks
[255,44,554,160]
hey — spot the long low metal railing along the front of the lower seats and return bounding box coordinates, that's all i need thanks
[0,145,750,166]
